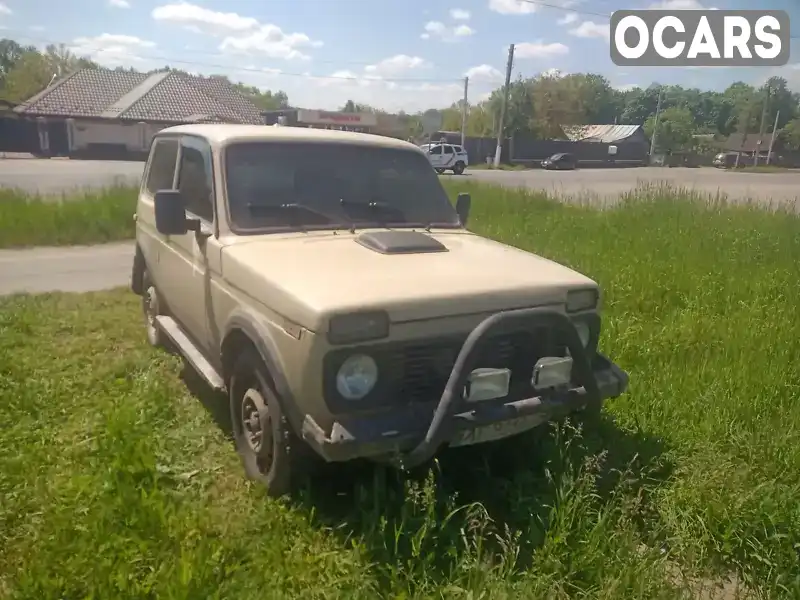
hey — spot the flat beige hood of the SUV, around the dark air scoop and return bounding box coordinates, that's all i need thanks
[222,230,595,331]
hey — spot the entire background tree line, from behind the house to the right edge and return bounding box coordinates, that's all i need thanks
[0,39,800,151]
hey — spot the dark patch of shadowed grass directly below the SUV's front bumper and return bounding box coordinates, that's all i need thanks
[293,415,672,580]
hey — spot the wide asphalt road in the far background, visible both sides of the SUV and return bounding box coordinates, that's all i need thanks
[0,159,800,202]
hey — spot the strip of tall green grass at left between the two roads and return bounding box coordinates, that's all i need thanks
[0,186,137,248]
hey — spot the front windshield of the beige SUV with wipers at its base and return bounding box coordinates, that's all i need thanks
[225,141,460,233]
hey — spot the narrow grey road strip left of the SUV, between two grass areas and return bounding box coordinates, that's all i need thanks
[0,242,133,296]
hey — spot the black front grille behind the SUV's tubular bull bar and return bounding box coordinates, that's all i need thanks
[382,328,563,402]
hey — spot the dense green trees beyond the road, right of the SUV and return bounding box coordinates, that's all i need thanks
[443,73,800,151]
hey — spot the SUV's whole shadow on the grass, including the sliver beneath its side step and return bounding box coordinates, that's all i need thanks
[181,360,672,590]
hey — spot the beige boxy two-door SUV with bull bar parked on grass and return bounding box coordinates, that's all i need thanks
[131,125,628,495]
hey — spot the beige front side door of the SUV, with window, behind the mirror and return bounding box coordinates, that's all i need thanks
[169,135,220,350]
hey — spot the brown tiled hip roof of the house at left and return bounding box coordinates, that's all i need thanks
[15,69,264,124]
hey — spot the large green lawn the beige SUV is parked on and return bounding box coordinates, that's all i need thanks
[0,182,800,600]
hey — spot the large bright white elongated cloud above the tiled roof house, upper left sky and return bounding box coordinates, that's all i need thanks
[152,2,322,59]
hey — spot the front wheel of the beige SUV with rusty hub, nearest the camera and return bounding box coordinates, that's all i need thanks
[228,348,314,498]
